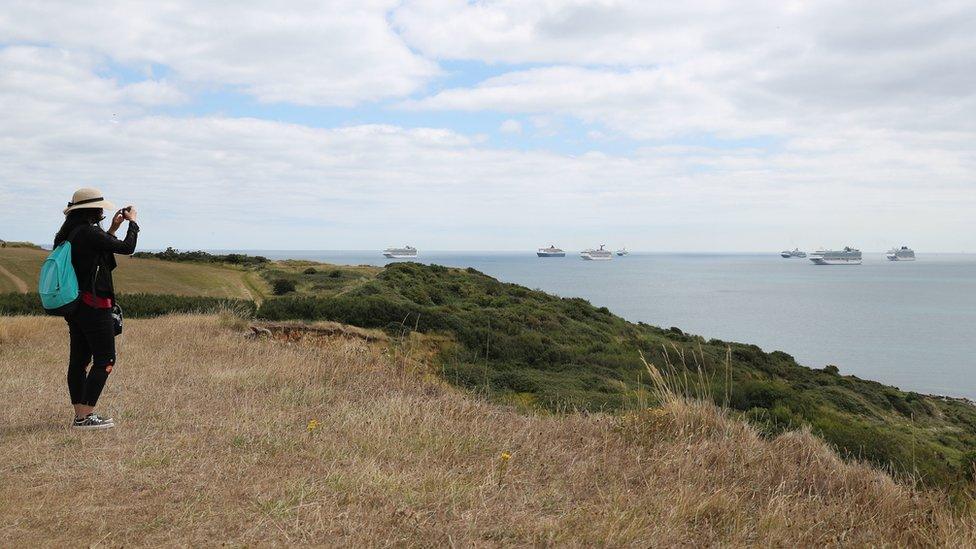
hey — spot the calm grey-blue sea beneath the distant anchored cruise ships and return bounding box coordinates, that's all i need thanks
[236,251,976,399]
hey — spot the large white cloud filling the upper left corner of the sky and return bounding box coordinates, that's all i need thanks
[0,0,438,105]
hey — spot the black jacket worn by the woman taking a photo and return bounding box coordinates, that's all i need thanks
[71,221,139,300]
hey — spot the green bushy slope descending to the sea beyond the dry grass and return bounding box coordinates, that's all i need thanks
[260,263,976,485]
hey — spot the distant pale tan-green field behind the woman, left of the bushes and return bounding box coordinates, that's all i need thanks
[0,248,263,299]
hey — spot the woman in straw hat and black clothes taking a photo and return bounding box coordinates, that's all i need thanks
[54,188,139,429]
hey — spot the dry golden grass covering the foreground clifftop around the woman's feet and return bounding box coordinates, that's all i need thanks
[0,316,976,546]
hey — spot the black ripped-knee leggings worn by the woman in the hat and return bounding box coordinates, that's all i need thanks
[66,303,115,406]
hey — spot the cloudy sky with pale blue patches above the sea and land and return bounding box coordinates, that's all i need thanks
[0,0,976,251]
